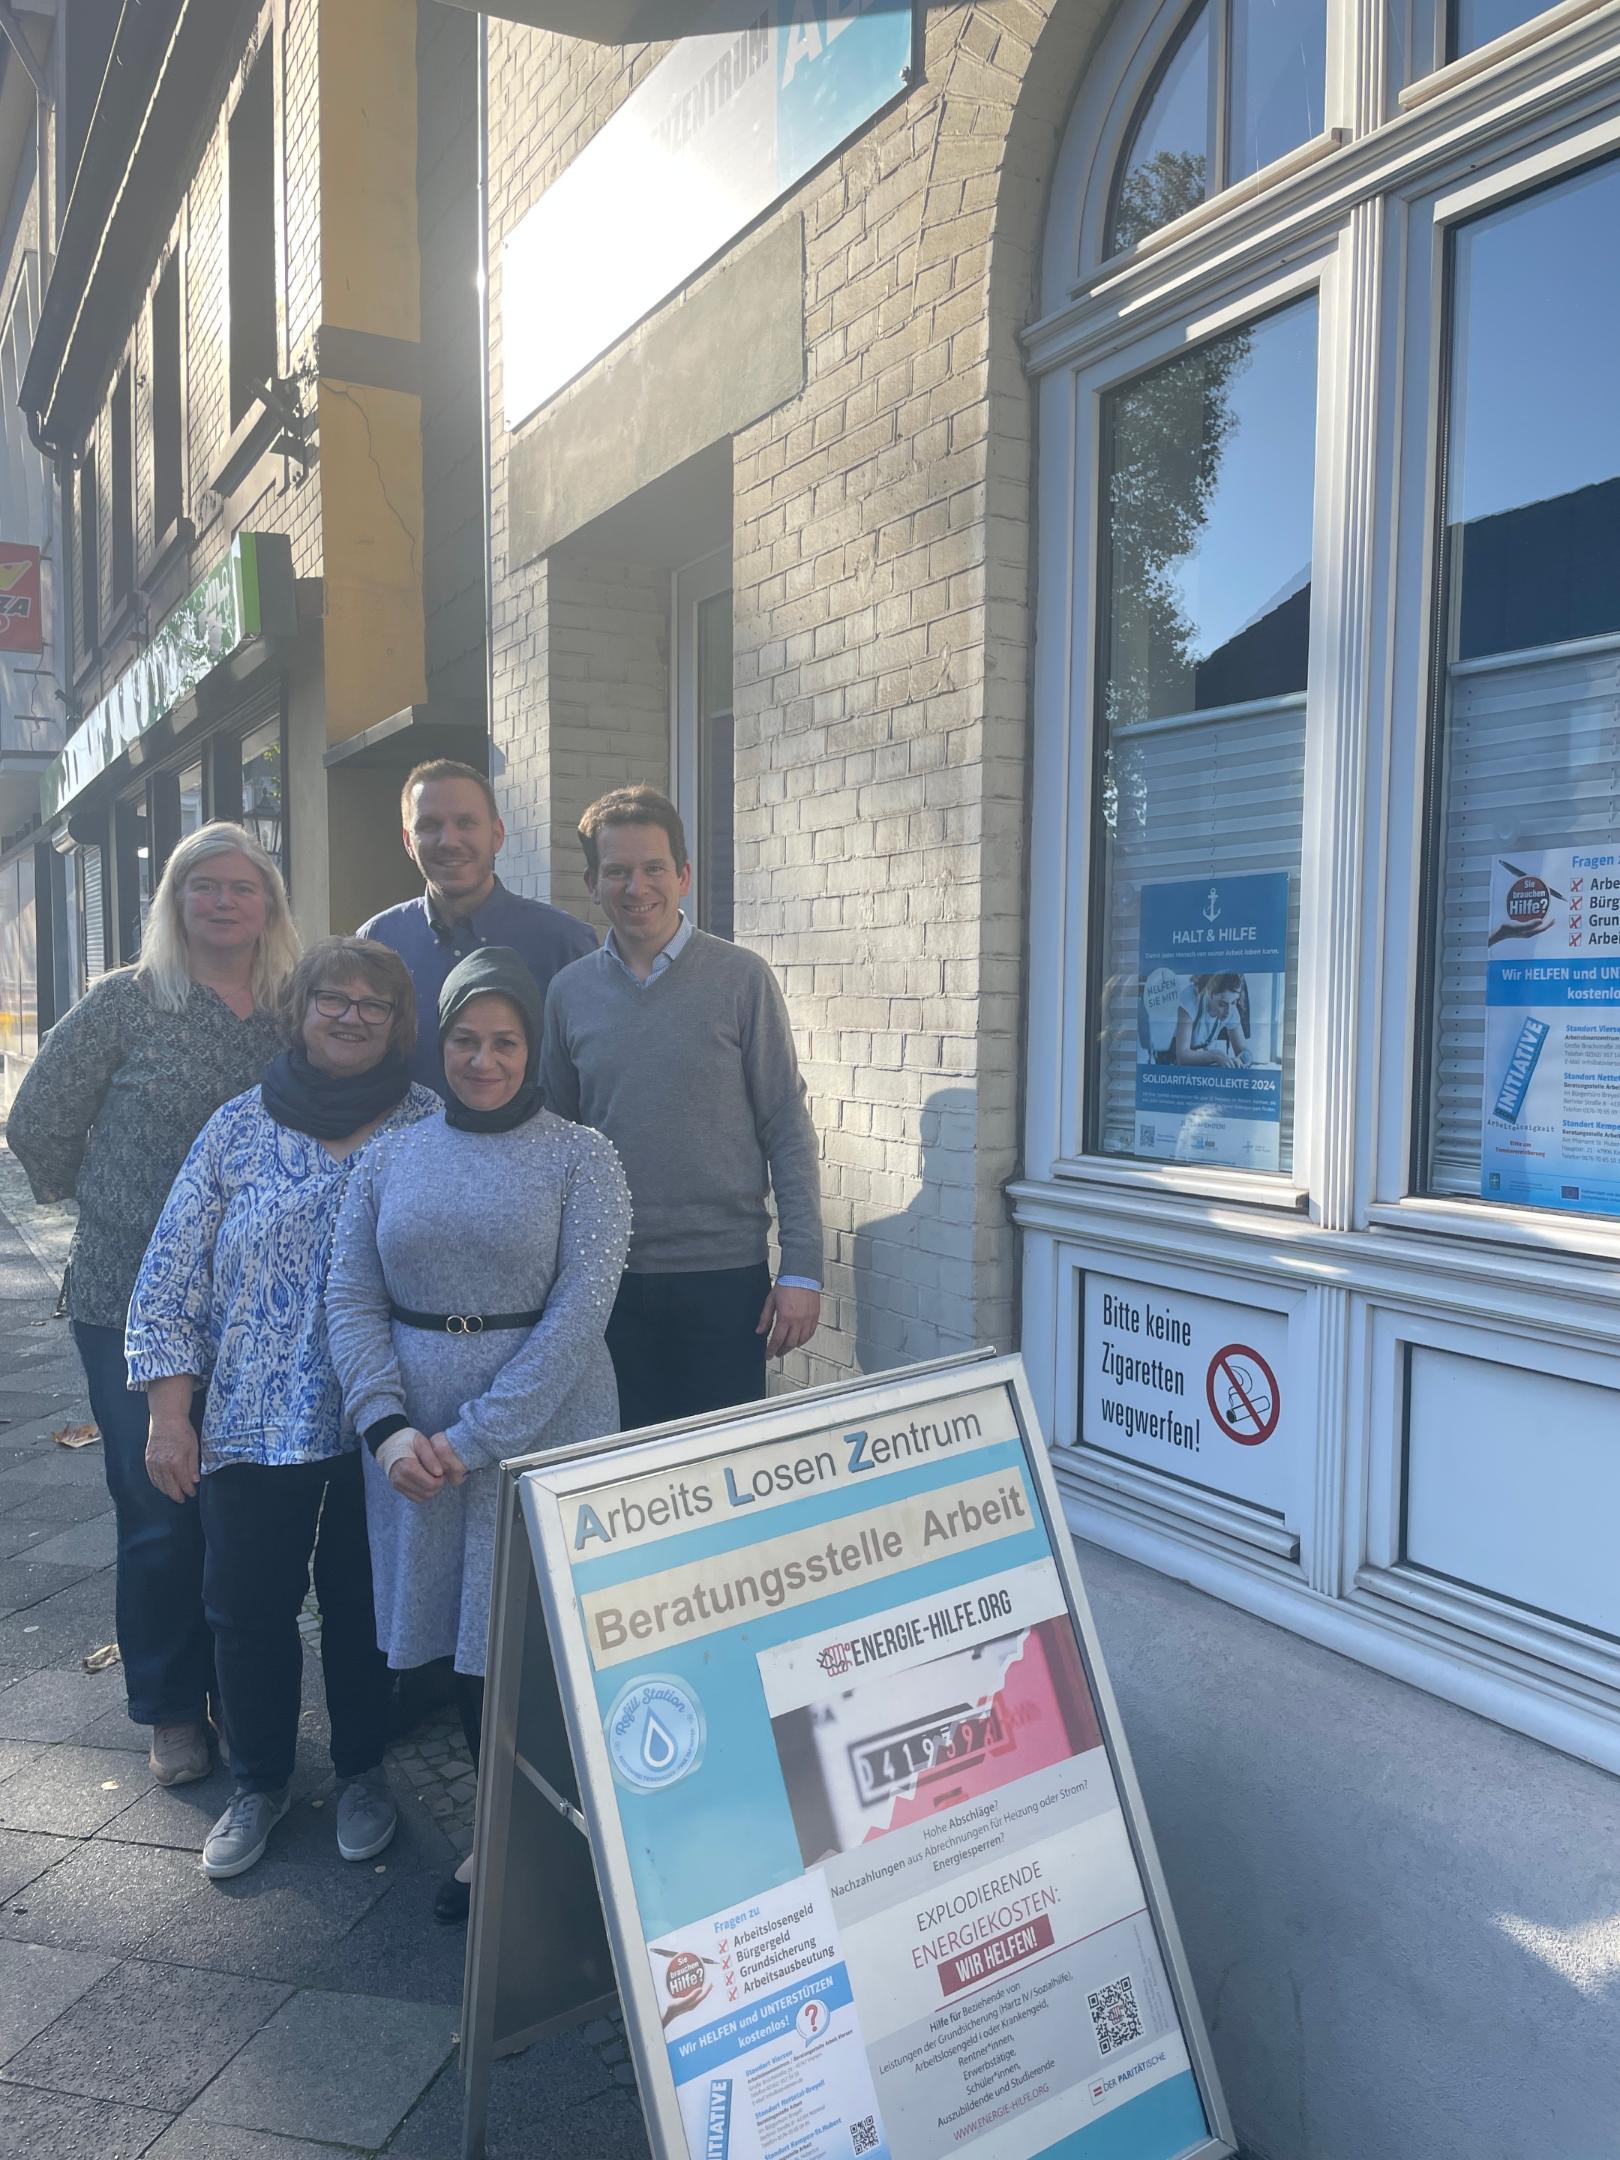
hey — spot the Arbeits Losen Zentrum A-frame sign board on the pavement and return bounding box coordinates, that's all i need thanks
[492,1359,1227,2160]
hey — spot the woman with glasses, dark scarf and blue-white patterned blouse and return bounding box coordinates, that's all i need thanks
[127,937,438,1877]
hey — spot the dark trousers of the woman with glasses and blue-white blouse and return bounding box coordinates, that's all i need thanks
[201,1454,389,1793]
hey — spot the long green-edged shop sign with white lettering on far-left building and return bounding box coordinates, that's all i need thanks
[39,534,294,819]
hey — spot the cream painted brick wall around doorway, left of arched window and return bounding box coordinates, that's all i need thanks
[490,0,1099,1380]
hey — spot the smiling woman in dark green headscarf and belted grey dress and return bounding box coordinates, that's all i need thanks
[326,946,631,1922]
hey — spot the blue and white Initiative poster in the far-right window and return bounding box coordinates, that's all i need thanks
[1480,847,1620,1214]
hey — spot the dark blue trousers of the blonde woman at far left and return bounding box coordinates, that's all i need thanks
[73,1320,214,1726]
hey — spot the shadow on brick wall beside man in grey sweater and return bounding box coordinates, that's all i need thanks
[853,1086,978,1372]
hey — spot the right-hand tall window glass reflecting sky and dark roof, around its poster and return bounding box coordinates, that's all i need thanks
[1430,162,1620,1197]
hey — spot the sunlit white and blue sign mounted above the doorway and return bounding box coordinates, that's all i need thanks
[501,0,914,428]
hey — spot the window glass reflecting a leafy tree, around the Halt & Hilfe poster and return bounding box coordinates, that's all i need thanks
[1093,300,1315,1169]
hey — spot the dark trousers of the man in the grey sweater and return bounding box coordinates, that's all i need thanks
[607,1261,771,1432]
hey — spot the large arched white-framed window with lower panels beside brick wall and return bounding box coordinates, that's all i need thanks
[1032,0,1620,1767]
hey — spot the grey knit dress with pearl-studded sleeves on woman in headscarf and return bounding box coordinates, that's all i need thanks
[326,1110,631,1672]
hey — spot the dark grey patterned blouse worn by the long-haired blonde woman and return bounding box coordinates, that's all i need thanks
[6,968,285,1328]
